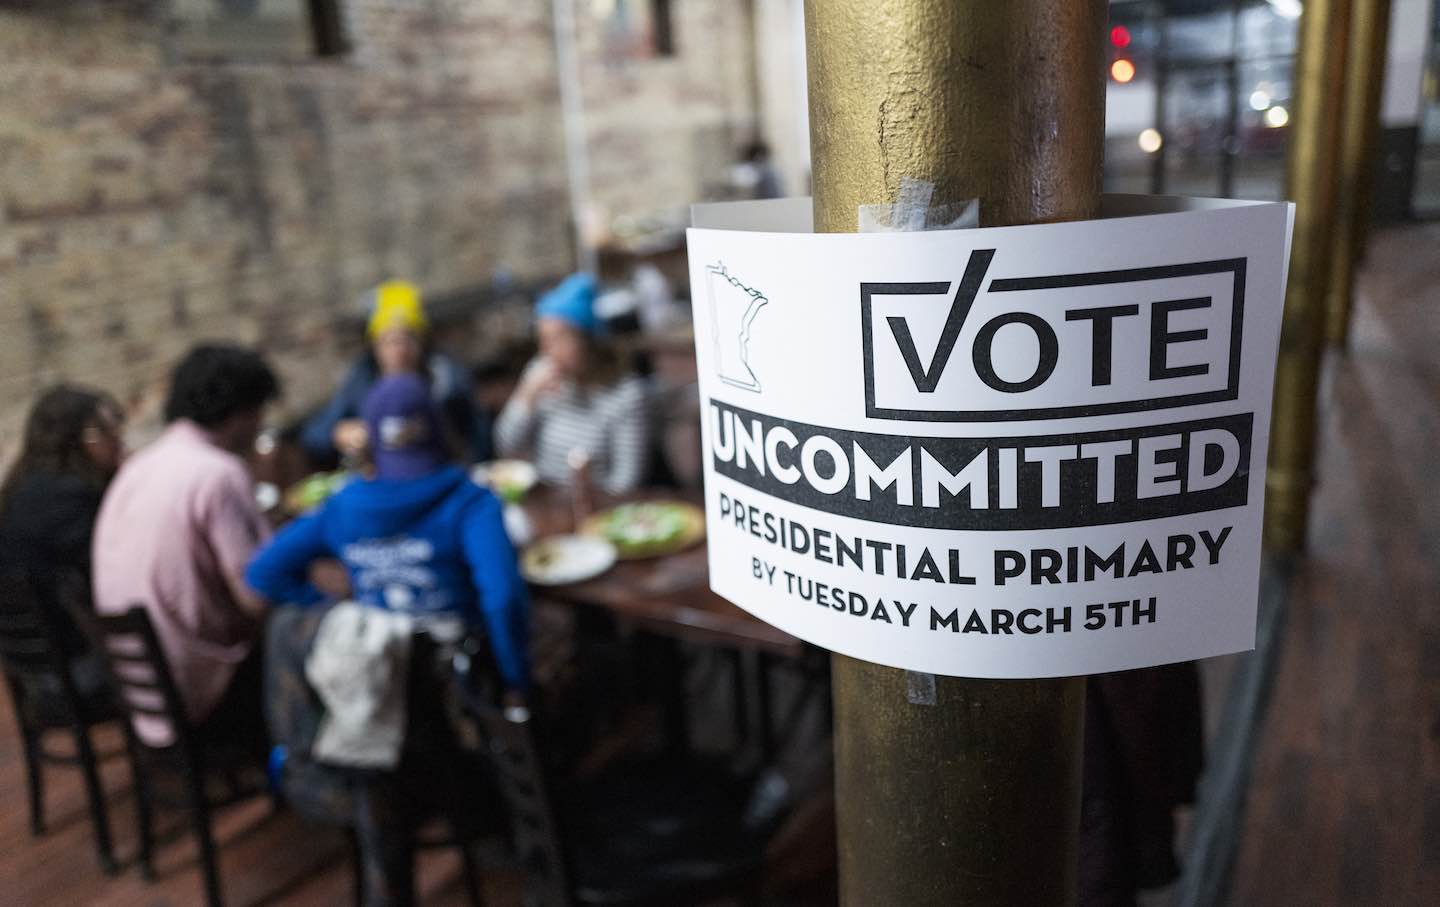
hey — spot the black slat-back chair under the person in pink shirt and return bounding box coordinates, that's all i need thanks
[94,606,266,907]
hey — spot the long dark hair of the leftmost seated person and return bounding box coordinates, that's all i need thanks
[0,384,121,508]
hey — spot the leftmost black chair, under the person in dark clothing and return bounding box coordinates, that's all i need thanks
[0,577,121,875]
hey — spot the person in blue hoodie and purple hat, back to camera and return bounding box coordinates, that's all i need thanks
[245,374,530,692]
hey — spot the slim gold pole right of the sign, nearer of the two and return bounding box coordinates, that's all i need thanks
[1264,0,1351,554]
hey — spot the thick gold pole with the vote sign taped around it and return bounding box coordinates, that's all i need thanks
[805,0,1106,907]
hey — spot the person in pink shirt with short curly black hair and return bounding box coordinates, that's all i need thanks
[92,346,279,753]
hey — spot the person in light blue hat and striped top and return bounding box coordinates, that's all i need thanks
[495,274,649,495]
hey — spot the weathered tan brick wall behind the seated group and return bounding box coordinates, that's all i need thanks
[0,0,753,462]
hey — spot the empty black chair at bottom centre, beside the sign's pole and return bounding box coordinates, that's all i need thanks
[456,642,770,907]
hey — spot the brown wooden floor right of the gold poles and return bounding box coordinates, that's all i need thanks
[1230,225,1440,906]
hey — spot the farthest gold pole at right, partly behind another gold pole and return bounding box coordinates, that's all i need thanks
[1325,0,1390,346]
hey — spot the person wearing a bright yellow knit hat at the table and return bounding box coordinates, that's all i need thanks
[301,281,491,464]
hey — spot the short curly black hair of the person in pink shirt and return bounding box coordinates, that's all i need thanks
[166,344,279,429]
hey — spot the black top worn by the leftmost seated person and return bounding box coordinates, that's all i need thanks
[0,472,104,656]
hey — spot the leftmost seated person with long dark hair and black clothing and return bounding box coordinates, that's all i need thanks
[0,384,125,697]
